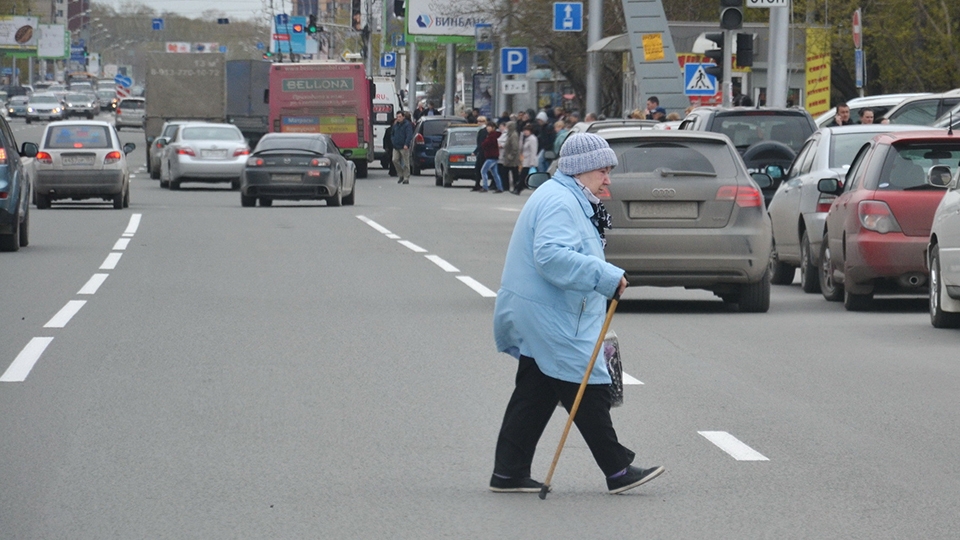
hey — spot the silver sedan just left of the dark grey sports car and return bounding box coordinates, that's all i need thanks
[160,122,250,189]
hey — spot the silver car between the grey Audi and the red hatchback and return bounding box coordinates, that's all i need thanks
[768,124,923,293]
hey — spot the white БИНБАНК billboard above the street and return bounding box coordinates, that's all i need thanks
[406,0,491,43]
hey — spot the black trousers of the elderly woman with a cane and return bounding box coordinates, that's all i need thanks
[493,356,636,478]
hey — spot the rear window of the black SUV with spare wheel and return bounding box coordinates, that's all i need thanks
[711,114,813,152]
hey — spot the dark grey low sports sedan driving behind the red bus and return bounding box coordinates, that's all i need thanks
[240,133,357,206]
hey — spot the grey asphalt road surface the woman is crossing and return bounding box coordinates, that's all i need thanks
[0,115,960,539]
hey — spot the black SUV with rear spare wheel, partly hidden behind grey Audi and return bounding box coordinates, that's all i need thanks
[680,107,817,205]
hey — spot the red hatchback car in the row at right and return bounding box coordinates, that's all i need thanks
[817,131,960,311]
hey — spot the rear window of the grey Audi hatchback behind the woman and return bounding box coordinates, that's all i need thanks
[608,141,738,177]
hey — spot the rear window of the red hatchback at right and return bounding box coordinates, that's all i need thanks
[864,141,960,191]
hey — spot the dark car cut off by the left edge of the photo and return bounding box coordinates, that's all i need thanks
[0,118,38,251]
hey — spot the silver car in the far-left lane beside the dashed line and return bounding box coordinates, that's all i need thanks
[34,120,136,210]
